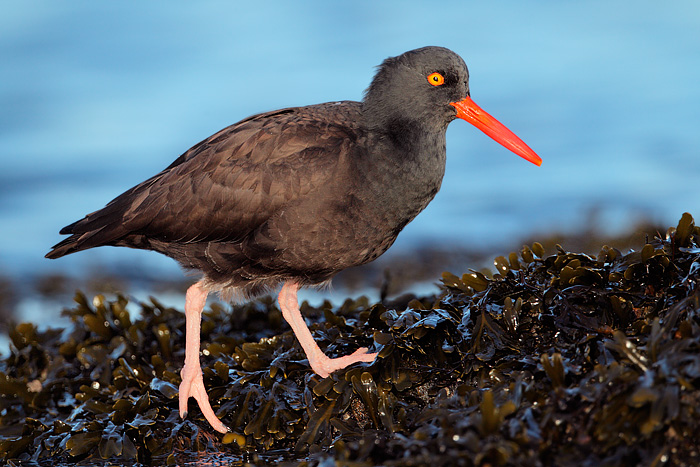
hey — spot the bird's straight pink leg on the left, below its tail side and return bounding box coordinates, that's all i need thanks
[180,282,229,433]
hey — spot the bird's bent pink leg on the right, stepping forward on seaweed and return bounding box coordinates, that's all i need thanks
[277,282,377,378]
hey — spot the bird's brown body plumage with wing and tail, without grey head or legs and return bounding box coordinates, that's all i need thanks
[47,98,444,296]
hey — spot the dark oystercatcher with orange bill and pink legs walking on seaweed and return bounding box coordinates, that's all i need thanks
[46,46,542,433]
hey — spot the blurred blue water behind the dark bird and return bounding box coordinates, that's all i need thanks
[0,0,700,286]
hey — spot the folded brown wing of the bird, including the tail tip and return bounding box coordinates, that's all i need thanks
[47,102,360,257]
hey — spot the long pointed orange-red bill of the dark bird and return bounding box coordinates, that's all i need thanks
[450,97,542,165]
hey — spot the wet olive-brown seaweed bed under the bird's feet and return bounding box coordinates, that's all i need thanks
[0,214,700,466]
